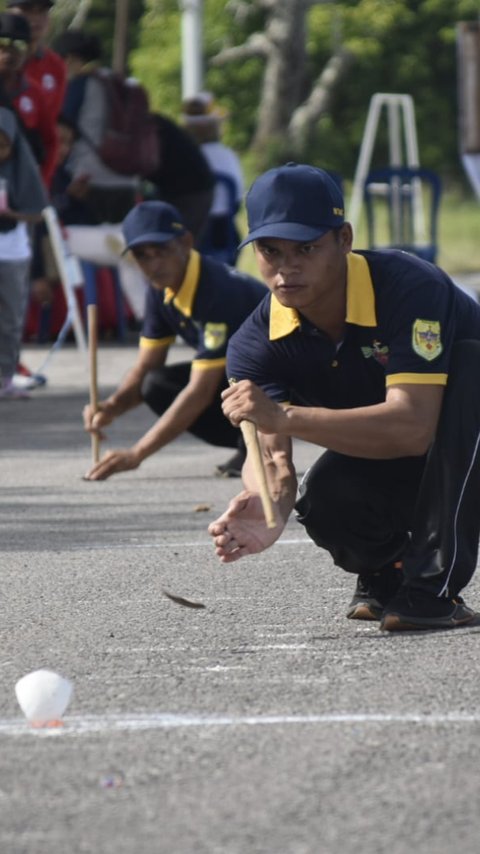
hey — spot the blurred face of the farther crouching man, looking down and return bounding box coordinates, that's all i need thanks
[131,234,191,291]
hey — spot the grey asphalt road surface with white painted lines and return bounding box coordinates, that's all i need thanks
[0,345,480,854]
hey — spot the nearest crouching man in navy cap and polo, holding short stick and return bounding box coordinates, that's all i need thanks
[209,163,480,631]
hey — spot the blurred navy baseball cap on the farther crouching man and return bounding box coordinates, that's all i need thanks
[122,202,187,252]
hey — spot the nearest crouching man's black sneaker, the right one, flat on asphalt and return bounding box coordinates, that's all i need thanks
[380,586,480,632]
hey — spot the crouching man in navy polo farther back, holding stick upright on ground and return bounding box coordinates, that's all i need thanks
[83,201,267,480]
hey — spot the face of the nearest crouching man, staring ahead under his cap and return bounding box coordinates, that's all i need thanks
[255,226,352,312]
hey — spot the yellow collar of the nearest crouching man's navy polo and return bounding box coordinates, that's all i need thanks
[269,252,377,341]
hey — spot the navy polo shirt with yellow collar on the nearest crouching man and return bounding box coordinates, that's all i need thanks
[227,250,480,409]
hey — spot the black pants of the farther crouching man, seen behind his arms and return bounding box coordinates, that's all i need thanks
[142,362,243,448]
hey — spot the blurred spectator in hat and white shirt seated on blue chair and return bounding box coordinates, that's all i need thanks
[182,92,244,262]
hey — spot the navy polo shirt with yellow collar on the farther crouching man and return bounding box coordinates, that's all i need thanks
[140,250,267,369]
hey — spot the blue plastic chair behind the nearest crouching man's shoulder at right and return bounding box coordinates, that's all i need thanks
[364,166,442,264]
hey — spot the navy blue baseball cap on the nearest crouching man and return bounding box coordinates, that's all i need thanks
[239,163,345,248]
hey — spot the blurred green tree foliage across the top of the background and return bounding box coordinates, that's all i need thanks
[48,0,478,186]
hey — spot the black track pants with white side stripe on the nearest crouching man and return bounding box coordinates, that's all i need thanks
[296,341,480,596]
